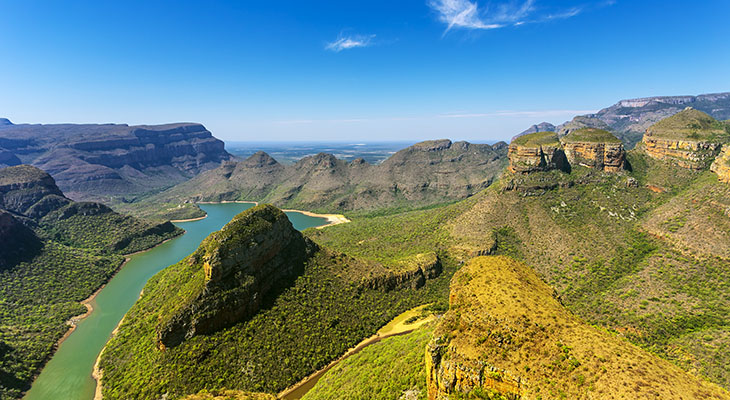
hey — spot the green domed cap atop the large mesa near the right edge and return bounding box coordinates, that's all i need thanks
[647,108,730,141]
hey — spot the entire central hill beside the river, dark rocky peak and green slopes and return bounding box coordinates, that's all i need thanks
[100,206,456,399]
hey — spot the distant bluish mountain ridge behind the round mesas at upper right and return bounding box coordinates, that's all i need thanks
[555,93,730,149]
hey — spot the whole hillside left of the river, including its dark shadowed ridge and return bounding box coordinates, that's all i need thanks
[0,165,182,399]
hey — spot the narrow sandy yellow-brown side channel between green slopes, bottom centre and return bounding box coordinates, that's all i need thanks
[277,304,436,400]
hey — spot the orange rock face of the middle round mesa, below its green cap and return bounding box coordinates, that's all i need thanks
[563,142,626,172]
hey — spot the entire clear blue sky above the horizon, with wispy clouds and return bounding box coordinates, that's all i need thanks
[0,0,730,142]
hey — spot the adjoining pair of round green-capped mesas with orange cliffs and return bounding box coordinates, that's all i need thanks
[508,128,626,174]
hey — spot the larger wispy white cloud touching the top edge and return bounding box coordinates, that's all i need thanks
[427,0,604,34]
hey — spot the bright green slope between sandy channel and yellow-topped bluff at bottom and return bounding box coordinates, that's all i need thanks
[302,327,433,400]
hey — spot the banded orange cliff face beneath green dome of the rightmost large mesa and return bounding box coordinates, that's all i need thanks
[643,134,722,170]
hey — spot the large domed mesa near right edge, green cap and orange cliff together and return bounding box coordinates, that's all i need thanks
[643,107,730,170]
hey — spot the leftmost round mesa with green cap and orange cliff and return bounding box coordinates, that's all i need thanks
[507,132,568,174]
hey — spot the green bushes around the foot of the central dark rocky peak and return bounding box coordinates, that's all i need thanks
[96,245,456,399]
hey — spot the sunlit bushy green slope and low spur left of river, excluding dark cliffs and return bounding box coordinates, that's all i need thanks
[0,213,180,399]
